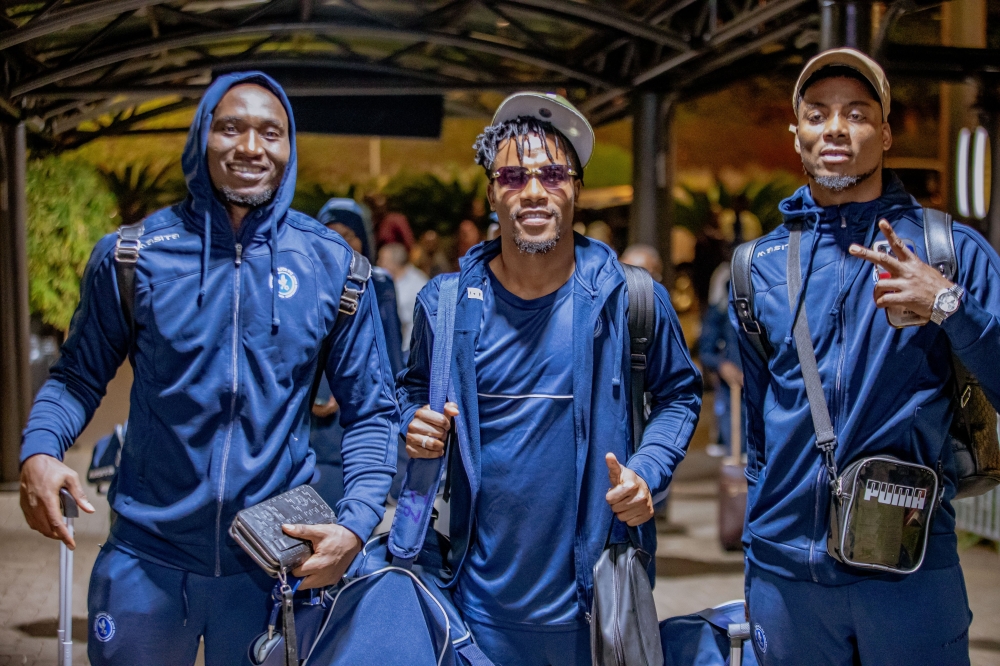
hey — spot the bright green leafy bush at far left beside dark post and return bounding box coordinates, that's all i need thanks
[27,156,120,330]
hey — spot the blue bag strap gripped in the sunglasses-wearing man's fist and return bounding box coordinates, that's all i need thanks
[388,275,458,569]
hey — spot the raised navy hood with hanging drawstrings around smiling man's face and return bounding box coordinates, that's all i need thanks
[181,72,298,328]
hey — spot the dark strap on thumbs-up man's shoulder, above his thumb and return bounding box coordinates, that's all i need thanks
[621,264,656,453]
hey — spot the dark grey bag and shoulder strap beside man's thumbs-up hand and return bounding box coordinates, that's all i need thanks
[590,264,663,666]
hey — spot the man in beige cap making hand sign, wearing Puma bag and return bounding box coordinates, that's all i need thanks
[730,49,1000,666]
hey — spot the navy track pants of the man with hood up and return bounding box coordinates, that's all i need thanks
[87,544,274,666]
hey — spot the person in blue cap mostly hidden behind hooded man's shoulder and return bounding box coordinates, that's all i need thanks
[309,198,407,506]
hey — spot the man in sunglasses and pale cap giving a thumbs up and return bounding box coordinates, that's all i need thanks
[397,93,701,666]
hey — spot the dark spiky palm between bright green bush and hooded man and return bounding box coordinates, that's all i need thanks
[101,162,187,224]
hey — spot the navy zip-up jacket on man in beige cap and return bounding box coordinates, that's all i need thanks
[730,170,1000,585]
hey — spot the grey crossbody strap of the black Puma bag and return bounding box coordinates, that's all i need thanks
[787,223,837,482]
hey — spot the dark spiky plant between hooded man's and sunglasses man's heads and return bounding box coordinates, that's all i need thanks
[383,168,486,237]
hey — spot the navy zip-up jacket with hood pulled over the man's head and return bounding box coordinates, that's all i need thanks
[21,72,399,576]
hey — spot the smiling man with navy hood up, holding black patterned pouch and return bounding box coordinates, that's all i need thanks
[21,72,398,666]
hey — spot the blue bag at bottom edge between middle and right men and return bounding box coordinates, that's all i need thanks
[660,599,757,666]
